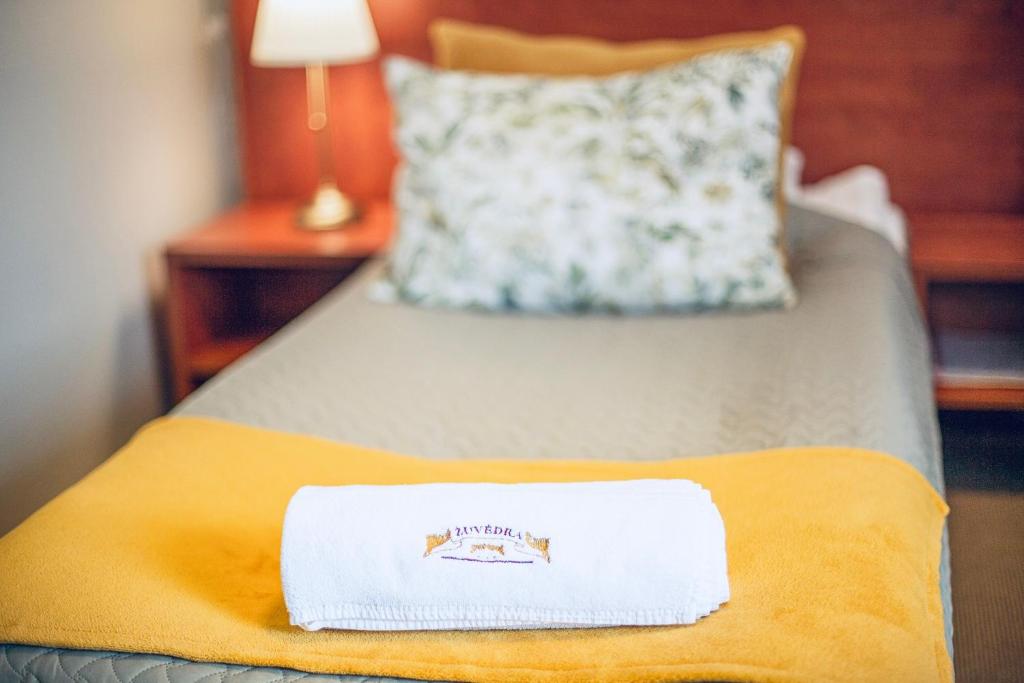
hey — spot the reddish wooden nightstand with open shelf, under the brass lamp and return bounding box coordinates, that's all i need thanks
[165,203,392,401]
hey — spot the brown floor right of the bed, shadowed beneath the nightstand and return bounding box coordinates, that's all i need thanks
[939,412,1024,683]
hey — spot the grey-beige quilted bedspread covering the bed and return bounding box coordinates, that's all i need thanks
[0,208,951,683]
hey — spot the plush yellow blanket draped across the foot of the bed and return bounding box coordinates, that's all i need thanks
[0,418,951,682]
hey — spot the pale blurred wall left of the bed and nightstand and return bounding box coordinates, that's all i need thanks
[0,0,239,533]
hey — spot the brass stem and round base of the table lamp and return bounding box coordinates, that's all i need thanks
[299,61,357,229]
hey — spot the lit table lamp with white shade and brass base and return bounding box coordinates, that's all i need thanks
[250,0,380,230]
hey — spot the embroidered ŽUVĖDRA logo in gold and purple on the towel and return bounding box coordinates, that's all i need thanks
[423,524,551,564]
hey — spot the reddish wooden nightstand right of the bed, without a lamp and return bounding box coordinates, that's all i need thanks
[910,213,1024,410]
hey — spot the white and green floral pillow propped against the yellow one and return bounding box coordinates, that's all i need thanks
[376,42,796,312]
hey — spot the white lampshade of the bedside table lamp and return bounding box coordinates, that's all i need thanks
[250,0,380,67]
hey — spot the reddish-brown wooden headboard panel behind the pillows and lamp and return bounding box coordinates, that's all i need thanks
[232,0,1024,212]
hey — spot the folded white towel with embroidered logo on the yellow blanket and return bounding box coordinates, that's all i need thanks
[281,479,729,631]
